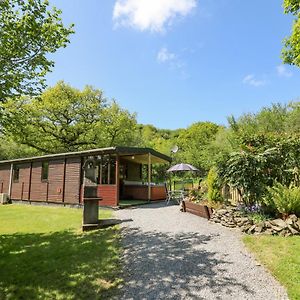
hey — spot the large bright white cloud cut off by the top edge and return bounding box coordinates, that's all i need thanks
[113,0,197,32]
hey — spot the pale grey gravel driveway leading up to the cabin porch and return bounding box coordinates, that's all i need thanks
[116,203,288,300]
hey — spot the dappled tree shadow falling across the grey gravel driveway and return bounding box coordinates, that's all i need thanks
[120,228,254,299]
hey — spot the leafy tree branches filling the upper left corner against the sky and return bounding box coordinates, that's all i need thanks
[0,0,73,102]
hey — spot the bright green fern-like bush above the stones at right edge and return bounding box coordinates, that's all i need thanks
[263,183,300,217]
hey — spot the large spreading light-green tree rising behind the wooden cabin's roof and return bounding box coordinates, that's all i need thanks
[2,82,135,153]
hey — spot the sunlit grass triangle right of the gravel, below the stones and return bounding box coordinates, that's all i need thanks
[244,235,300,300]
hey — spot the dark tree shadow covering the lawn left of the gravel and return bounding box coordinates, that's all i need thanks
[0,228,119,299]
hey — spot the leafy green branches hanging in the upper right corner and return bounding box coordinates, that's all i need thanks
[282,0,300,67]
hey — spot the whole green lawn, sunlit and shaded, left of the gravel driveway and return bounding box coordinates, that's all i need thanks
[0,205,121,299]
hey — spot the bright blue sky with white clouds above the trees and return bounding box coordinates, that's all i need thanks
[47,0,300,129]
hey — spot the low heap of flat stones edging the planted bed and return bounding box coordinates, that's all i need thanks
[210,207,300,236]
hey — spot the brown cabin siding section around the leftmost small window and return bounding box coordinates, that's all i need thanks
[11,163,30,200]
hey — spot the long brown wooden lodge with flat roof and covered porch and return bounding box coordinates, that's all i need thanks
[0,147,171,206]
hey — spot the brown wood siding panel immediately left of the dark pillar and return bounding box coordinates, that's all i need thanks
[65,157,81,203]
